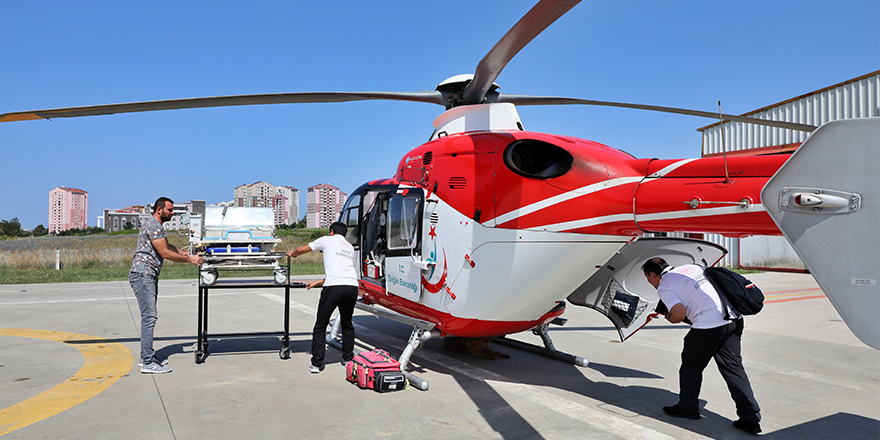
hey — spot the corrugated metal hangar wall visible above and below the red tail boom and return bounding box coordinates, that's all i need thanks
[700,71,880,270]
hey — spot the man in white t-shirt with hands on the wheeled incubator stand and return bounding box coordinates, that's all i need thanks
[287,222,358,373]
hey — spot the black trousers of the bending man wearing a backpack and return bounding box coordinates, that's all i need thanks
[678,319,761,422]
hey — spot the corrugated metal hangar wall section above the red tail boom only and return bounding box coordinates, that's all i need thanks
[700,71,880,155]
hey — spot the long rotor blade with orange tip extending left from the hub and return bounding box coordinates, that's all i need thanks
[0,91,446,122]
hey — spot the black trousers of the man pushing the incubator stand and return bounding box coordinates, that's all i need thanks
[312,286,357,367]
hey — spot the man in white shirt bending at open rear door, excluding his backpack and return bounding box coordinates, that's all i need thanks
[642,258,761,434]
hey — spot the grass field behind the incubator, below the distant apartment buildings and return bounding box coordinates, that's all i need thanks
[0,229,326,284]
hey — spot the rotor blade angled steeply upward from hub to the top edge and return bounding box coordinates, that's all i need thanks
[463,0,581,104]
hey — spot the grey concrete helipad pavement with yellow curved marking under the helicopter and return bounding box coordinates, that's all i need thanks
[0,273,880,440]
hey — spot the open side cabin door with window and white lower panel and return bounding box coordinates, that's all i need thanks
[385,188,425,302]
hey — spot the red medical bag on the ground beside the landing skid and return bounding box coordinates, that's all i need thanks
[345,348,406,393]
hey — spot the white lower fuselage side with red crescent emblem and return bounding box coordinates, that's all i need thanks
[420,200,631,321]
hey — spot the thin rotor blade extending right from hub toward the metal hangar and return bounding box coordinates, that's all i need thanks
[493,93,817,132]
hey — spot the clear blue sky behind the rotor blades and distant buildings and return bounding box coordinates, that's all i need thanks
[0,0,880,229]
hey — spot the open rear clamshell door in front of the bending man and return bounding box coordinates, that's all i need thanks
[568,237,727,341]
